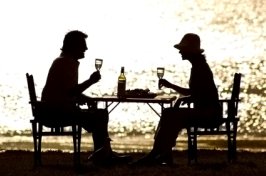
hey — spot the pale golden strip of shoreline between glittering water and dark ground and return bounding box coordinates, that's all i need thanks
[0,135,266,153]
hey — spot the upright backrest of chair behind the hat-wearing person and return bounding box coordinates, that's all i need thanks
[228,73,241,118]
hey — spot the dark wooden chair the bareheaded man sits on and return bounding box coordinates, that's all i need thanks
[26,73,81,166]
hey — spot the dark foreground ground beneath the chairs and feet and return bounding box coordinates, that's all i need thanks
[0,150,266,176]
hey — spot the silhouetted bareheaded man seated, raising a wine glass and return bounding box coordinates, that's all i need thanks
[41,30,131,164]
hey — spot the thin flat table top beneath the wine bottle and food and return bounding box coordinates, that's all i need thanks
[91,95,176,103]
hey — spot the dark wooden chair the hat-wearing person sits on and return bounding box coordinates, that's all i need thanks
[187,73,241,163]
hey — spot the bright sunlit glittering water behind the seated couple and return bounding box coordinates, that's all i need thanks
[0,0,266,151]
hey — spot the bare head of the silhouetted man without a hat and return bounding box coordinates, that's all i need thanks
[61,30,88,59]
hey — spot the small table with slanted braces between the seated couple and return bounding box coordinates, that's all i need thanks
[91,95,176,117]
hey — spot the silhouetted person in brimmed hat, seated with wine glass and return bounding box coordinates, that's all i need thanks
[134,33,222,165]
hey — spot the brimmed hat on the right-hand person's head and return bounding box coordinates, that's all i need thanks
[174,33,204,53]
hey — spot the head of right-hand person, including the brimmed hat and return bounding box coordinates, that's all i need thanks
[174,33,204,60]
